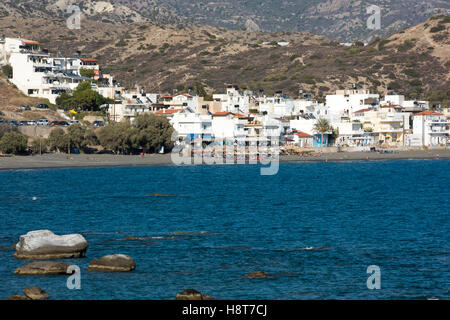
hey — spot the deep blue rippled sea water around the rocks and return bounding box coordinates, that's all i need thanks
[0,160,450,300]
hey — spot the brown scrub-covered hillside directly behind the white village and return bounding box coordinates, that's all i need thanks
[0,16,450,104]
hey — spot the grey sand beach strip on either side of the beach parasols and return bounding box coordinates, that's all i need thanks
[0,149,450,170]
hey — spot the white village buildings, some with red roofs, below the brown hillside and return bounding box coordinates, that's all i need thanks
[0,37,450,148]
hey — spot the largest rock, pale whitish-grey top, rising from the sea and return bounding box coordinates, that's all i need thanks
[14,230,88,259]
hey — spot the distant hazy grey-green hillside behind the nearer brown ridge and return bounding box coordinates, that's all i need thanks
[0,0,450,42]
